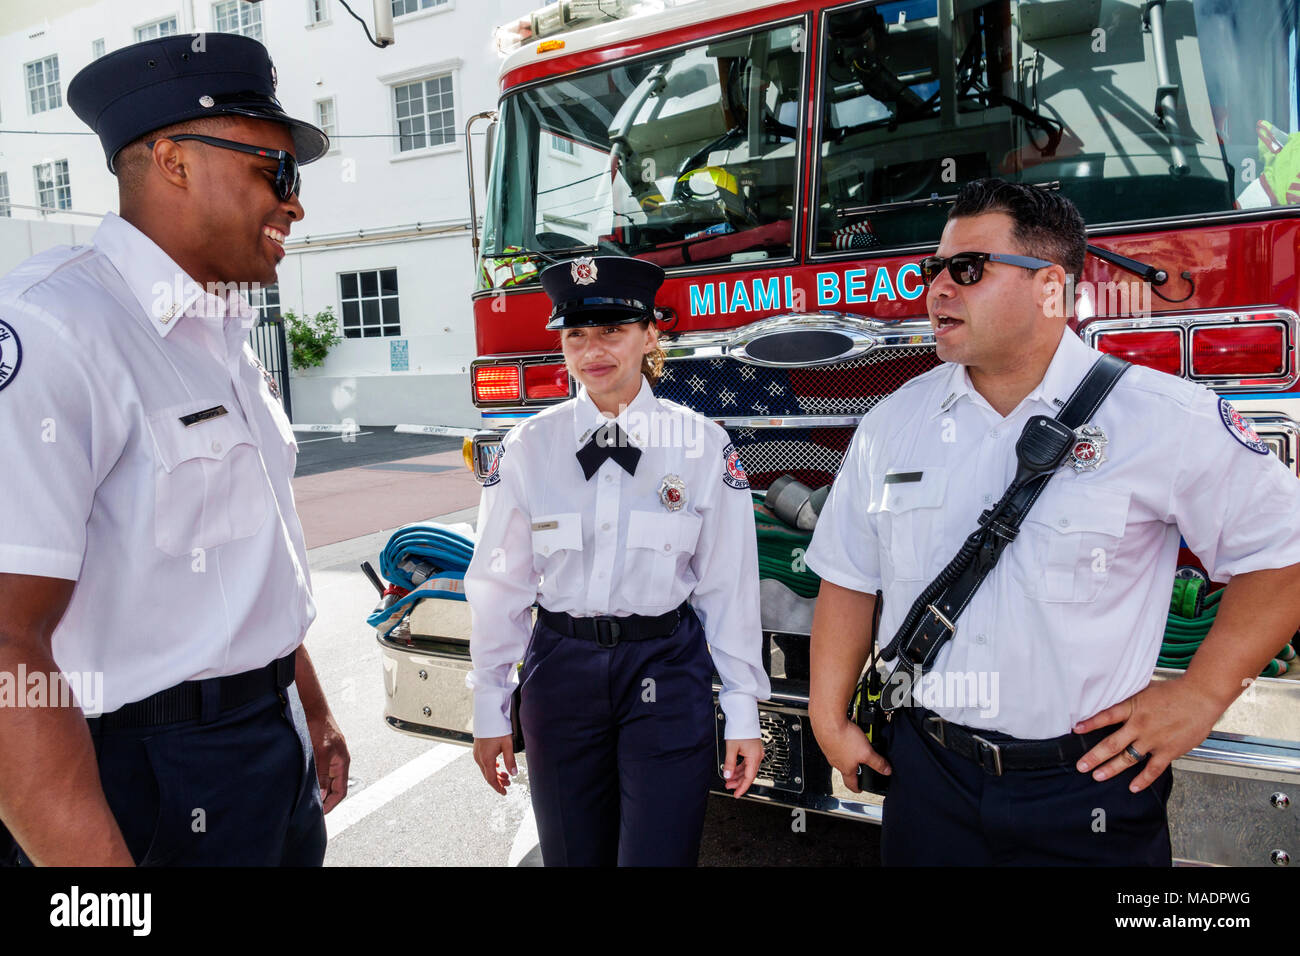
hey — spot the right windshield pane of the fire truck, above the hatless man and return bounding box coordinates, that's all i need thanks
[815,0,1300,252]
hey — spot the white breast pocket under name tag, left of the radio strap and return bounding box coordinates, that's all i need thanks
[880,467,956,580]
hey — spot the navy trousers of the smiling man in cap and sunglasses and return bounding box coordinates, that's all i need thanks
[12,684,325,866]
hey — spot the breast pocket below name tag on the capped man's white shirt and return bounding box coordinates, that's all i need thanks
[148,399,270,555]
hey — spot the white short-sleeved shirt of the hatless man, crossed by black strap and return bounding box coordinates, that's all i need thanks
[806,330,1300,739]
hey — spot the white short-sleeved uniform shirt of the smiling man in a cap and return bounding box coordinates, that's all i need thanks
[0,215,316,711]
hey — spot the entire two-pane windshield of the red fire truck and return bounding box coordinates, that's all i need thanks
[478,0,1300,289]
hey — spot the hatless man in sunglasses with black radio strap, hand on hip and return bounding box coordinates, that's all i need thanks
[807,179,1300,866]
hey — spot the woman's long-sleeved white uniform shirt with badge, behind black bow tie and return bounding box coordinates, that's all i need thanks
[465,378,771,739]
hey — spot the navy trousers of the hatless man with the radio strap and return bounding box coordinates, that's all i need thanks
[880,710,1173,866]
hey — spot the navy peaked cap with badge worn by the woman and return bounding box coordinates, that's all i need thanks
[541,256,663,329]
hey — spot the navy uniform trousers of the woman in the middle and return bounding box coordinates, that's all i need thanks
[519,611,716,866]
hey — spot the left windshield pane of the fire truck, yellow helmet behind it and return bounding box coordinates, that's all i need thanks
[480,18,803,289]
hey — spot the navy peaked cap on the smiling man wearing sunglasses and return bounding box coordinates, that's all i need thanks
[68,34,329,173]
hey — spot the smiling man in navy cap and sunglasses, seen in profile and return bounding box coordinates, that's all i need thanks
[0,34,348,865]
